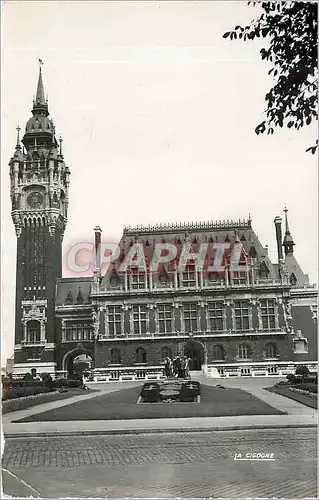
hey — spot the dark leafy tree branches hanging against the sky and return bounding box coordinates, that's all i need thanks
[223,1,318,154]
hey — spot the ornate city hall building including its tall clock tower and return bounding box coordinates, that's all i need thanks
[9,67,317,381]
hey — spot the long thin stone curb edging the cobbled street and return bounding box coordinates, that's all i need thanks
[4,423,317,439]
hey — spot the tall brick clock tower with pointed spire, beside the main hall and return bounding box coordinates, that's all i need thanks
[9,66,70,375]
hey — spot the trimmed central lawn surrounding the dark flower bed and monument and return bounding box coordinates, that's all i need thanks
[13,384,283,422]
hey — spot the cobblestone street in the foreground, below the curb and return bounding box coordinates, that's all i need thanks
[3,429,316,498]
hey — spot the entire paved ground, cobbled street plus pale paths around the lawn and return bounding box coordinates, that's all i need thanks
[3,374,317,498]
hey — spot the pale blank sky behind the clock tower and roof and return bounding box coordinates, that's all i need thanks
[1,0,318,361]
